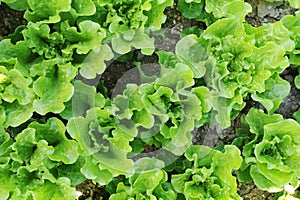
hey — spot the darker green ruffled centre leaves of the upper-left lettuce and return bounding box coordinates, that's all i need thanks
[23,20,105,60]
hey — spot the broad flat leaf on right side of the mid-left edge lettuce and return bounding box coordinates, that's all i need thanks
[30,60,77,115]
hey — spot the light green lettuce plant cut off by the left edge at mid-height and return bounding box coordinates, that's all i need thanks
[0,39,77,123]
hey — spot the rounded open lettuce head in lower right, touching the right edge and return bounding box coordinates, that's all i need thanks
[234,109,300,192]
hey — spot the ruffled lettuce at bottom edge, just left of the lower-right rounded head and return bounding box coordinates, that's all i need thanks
[171,146,242,200]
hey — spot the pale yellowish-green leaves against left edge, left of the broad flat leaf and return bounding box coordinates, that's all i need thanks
[0,40,36,128]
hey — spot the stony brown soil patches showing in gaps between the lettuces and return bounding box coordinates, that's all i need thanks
[0,0,300,200]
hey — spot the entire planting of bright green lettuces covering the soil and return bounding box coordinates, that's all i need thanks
[0,0,300,200]
